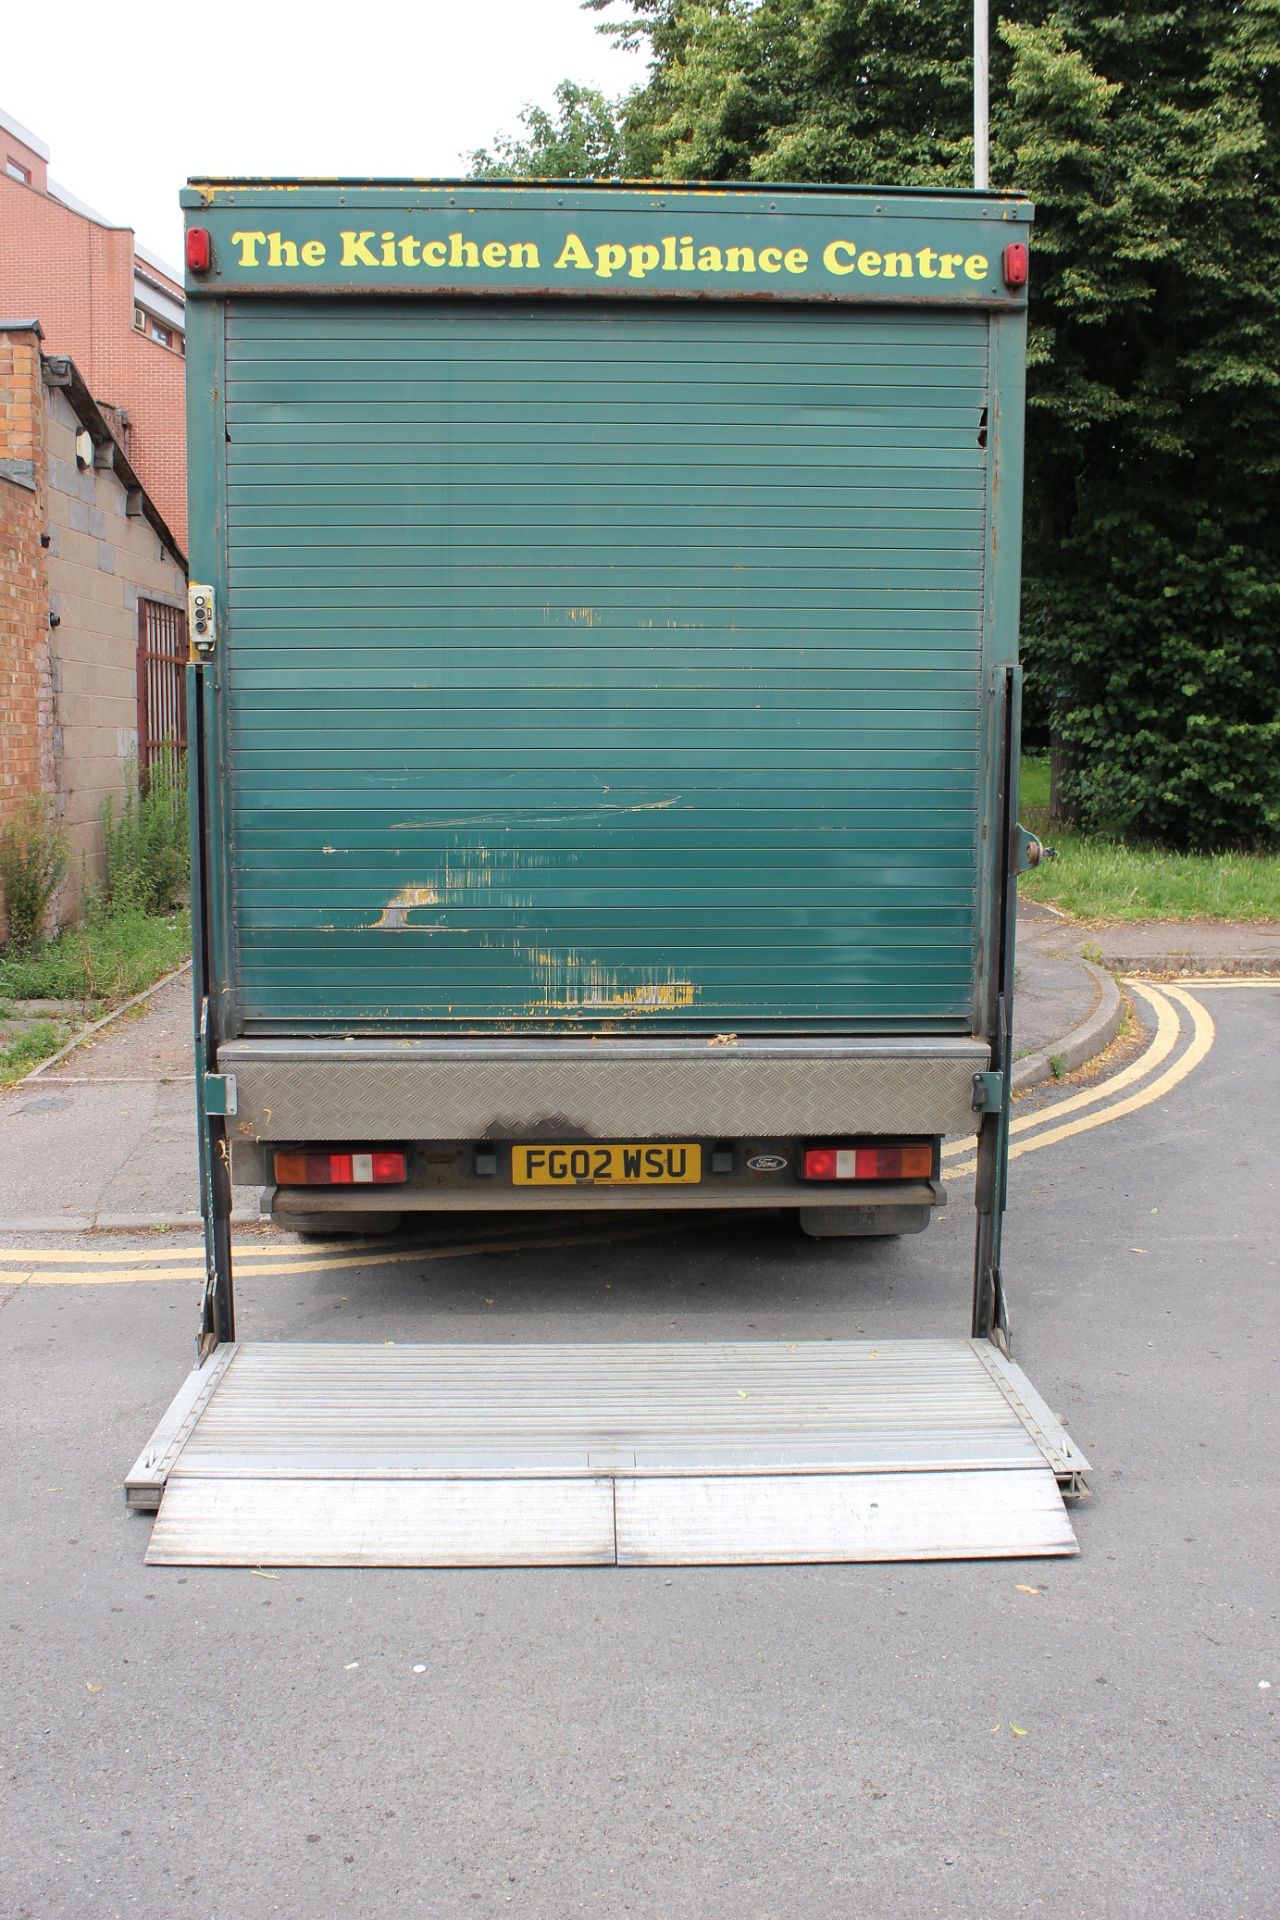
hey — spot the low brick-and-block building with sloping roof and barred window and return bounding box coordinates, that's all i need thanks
[0,319,186,931]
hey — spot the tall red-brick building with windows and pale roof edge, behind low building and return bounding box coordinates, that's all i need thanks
[0,111,186,547]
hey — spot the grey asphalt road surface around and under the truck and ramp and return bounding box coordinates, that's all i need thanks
[0,989,1280,1920]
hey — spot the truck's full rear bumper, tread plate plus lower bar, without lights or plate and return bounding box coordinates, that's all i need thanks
[219,1037,988,1223]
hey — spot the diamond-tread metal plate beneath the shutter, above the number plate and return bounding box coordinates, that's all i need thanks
[219,1035,990,1146]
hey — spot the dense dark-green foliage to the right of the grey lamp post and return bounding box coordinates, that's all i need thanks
[1000,0,1280,847]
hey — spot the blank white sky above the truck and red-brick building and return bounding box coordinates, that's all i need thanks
[0,0,645,267]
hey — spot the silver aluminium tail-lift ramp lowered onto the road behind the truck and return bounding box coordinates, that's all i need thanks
[127,1340,1088,1567]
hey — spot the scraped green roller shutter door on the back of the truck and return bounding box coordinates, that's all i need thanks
[225,300,986,1033]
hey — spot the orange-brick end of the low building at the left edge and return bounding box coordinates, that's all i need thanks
[0,332,54,944]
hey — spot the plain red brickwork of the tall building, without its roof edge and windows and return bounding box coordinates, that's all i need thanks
[0,175,186,549]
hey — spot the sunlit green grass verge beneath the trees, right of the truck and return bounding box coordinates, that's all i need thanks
[1020,755,1280,921]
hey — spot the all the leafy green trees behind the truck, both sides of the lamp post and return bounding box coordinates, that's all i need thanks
[477,0,1280,847]
